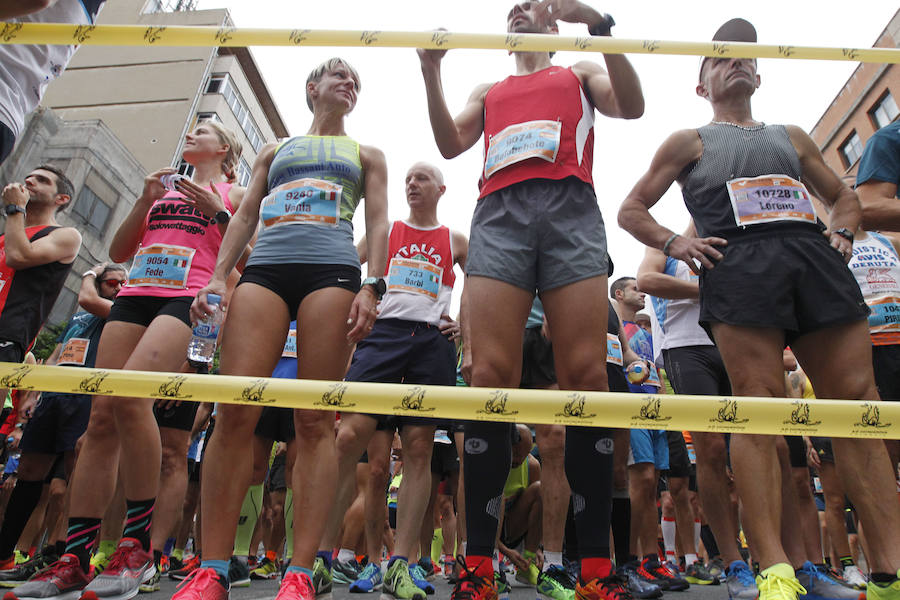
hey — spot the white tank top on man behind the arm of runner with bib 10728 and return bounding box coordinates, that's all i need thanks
[651,257,713,350]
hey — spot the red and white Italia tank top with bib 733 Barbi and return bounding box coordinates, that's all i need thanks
[378,221,456,324]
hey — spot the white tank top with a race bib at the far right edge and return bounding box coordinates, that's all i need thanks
[848,231,900,346]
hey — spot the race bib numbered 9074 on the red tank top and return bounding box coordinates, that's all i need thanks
[484,121,562,179]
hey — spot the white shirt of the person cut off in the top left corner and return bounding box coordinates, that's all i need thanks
[0,0,105,137]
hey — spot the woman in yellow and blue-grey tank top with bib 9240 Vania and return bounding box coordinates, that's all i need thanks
[181,58,388,600]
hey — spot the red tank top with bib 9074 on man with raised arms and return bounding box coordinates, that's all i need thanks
[478,67,594,199]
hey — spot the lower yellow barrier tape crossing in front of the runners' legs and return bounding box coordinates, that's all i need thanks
[0,363,900,439]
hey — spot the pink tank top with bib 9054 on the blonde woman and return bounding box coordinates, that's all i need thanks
[119,183,234,298]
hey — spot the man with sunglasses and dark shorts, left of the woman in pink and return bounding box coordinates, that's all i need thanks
[0,263,127,587]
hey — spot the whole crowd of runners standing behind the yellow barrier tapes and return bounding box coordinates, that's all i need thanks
[0,0,900,600]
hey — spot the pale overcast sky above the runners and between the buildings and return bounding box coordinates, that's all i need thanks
[198,0,897,313]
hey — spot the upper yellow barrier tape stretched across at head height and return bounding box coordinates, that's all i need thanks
[0,23,900,63]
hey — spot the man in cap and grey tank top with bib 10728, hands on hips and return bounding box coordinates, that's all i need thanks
[619,19,900,600]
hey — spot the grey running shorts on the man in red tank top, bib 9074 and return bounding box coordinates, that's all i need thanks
[466,177,607,292]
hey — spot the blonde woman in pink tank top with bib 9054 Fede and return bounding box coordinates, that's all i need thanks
[67,121,244,580]
